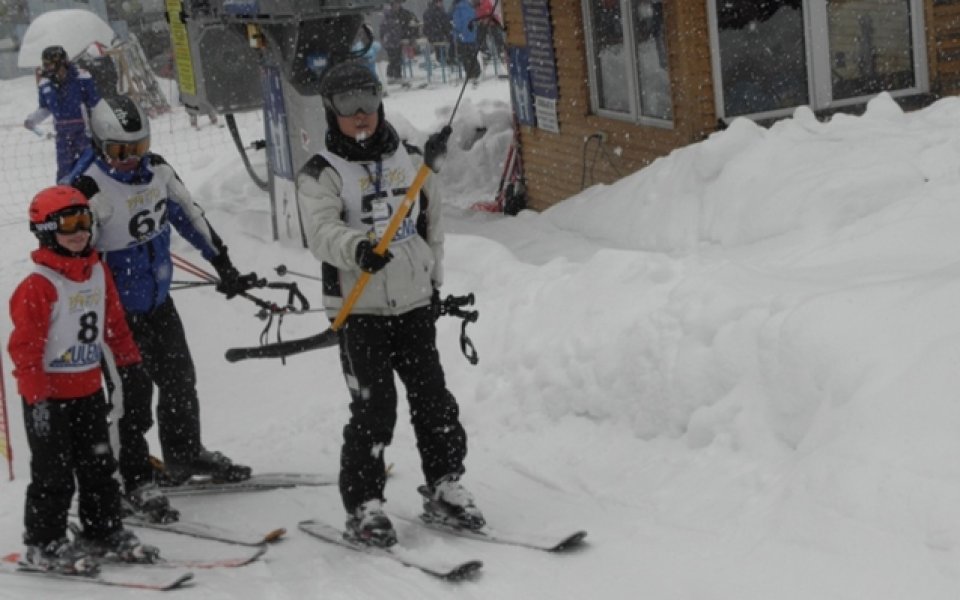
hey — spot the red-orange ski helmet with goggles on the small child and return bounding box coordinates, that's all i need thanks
[29,185,93,254]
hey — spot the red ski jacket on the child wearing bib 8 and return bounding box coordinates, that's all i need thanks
[7,248,141,404]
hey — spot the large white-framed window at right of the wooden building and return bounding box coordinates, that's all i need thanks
[708,0,928,118]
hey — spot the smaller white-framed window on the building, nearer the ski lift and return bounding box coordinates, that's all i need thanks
[583,0,673,124]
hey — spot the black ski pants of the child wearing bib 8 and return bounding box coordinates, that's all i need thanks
[23,391,121,546]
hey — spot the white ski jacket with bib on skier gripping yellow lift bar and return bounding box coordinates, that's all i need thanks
[297,144,443,319]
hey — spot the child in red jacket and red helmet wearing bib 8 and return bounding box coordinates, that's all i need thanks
[8,186,159,574]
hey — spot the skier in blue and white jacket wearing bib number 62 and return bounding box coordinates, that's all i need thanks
[65,96,259,494]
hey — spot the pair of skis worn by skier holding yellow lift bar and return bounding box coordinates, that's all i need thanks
[298,515,587,581]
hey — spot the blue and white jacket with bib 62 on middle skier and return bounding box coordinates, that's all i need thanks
[71,152,226,313]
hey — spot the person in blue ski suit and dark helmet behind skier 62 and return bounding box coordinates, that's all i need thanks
[23,46,100,182]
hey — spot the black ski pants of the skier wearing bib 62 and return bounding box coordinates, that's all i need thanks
[120,296,203,464]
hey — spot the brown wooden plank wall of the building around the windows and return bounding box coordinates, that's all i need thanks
[501,0,960,210]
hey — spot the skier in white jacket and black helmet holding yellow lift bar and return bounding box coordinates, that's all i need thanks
[298,61,484,547]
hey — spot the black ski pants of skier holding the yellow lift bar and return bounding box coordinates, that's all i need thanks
[340,307,467,514]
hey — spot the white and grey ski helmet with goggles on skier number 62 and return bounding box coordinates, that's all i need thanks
[90,96,150,167]
